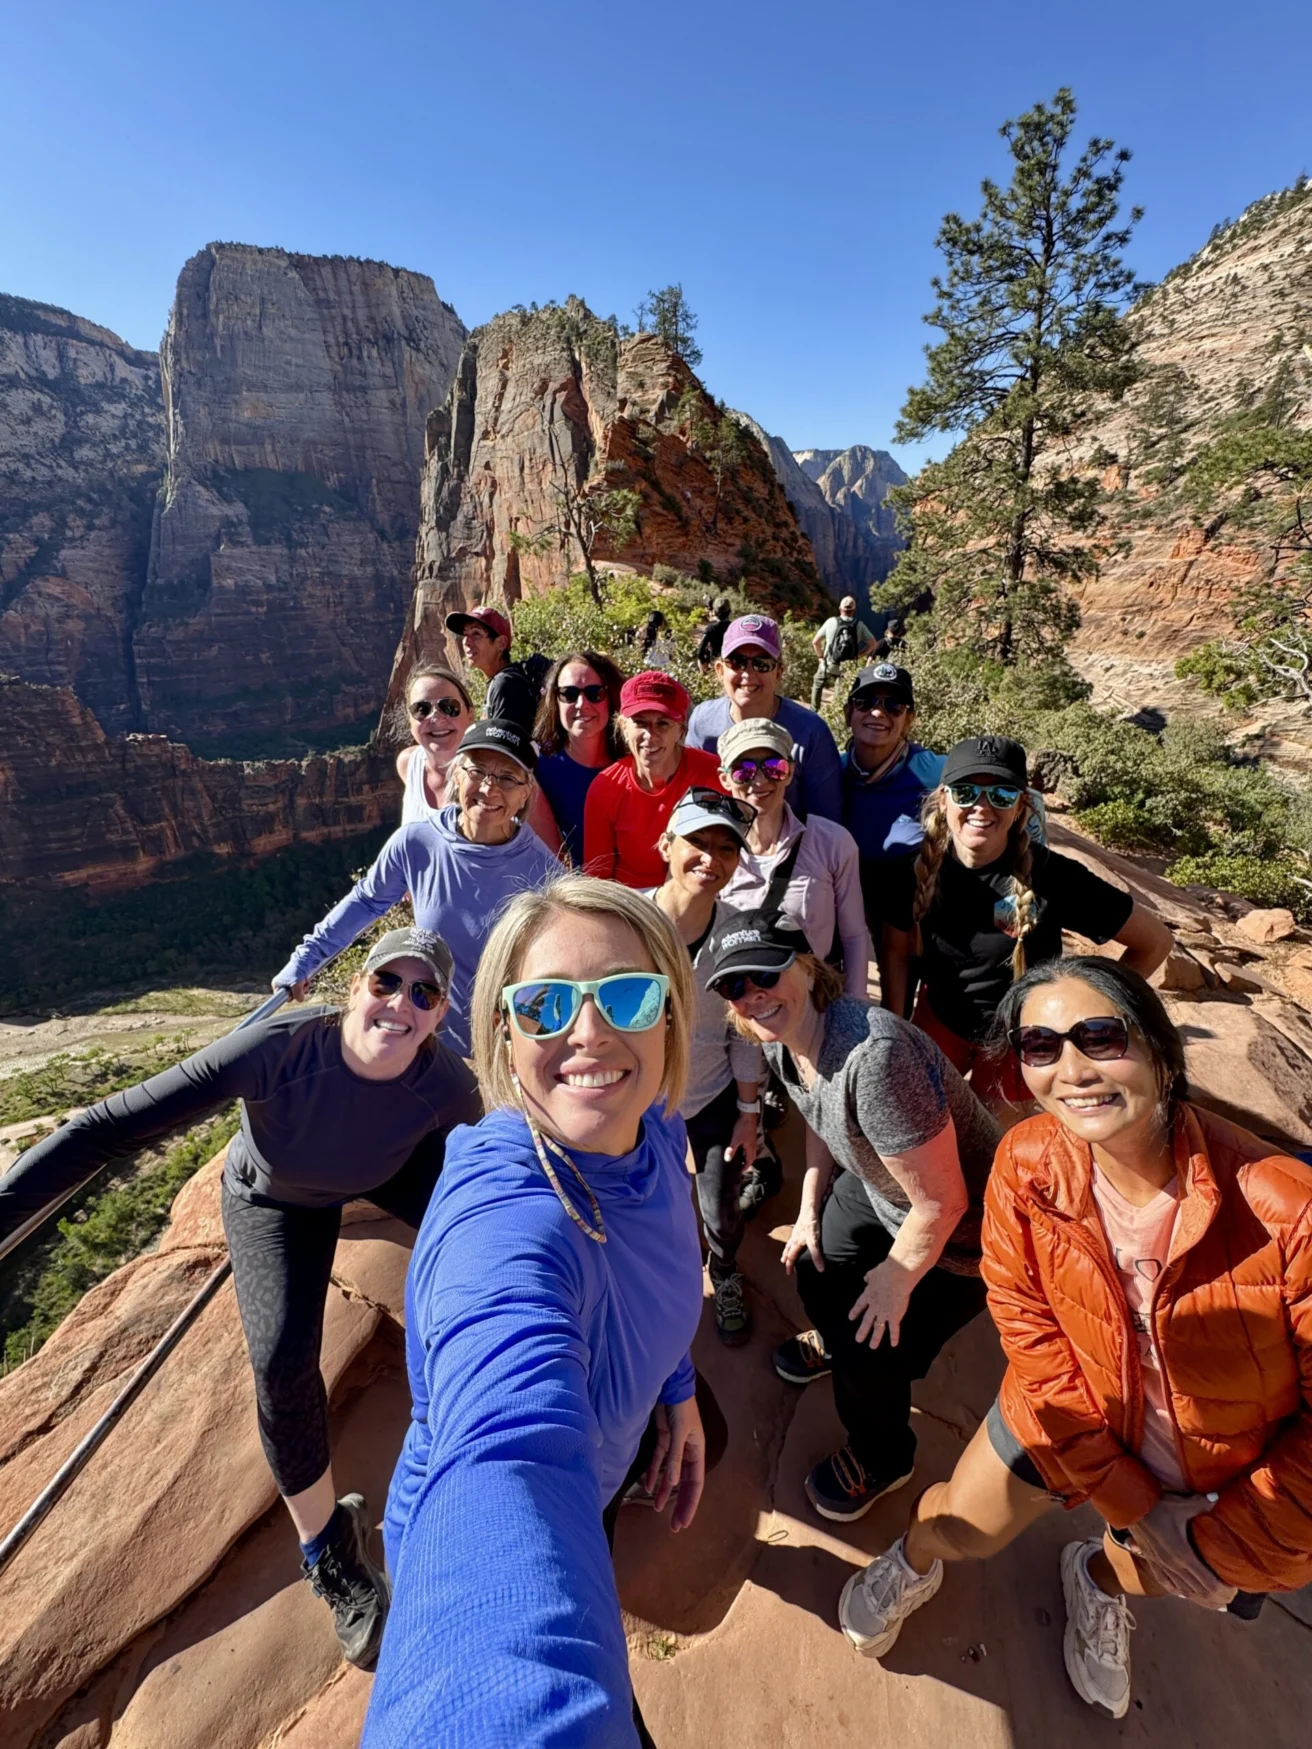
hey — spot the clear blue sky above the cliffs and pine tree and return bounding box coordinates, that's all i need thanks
[0,0,1312,460]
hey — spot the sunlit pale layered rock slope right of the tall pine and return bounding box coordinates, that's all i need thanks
[1078,184,1312,666]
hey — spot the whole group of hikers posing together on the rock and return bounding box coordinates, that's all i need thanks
[0,603,1312,1749]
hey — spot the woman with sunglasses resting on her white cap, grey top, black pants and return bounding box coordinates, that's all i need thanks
[651,789,761,1347]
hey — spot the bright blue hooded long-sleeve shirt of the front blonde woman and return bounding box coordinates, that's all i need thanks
[362,1111,701,1749]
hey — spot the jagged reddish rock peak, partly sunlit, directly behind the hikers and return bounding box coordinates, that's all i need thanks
[399,297,819,666]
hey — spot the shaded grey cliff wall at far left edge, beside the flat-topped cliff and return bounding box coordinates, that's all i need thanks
[0,296,164,731]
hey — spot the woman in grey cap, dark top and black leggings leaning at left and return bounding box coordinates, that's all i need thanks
[0,929,481,1667]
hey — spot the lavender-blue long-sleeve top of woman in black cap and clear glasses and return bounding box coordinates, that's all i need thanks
[273,805,562,1056]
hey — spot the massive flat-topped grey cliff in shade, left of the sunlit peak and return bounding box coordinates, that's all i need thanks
[133,243,465,747]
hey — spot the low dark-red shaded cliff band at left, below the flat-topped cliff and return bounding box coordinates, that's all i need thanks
[0,677,401,894]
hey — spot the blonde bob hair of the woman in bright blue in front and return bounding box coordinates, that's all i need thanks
[471,875,693,1111]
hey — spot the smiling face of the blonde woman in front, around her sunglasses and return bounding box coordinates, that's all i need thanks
[507,911,666,1154]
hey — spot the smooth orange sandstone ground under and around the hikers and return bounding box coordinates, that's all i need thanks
[0,836,1312,1749]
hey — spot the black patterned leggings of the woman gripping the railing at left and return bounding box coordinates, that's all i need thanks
[222,1140,443,1494]
